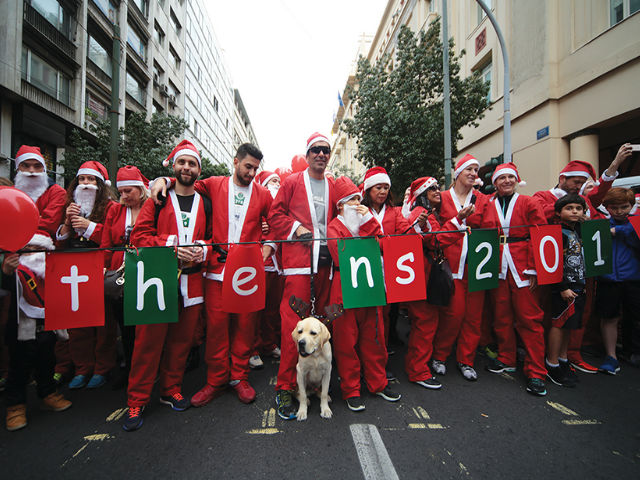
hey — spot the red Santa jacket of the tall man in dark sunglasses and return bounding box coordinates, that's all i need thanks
[269,169,337,275]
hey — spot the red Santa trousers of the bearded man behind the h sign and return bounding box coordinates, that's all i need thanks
[127,304,202,407]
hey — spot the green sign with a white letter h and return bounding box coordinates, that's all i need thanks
[124,248,178,325]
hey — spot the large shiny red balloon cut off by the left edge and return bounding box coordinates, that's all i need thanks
[0,187,40,252]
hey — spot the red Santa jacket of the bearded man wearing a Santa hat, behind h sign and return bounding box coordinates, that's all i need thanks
[131,190,210,307]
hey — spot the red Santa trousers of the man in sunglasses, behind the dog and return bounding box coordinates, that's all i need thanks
[276,267,331,390]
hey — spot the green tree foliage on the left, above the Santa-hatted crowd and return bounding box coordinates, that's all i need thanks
[62,113,229,185]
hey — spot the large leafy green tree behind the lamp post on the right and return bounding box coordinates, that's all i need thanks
[341,18,489,193]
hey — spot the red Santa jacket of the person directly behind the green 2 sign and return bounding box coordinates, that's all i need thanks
[438,187,489,280]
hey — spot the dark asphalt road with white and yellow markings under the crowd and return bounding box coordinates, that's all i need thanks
[0,334,640,480]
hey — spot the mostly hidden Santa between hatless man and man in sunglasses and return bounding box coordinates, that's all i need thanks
[249,170,284,370]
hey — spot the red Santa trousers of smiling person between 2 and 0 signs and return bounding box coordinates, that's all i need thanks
[491,272,547,379]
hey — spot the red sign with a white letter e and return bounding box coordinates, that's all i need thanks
[222,245,265,313]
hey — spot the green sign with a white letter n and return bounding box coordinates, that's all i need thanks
[338,238,386,308]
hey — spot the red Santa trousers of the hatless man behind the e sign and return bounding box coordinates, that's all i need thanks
[204,280,259,387]
